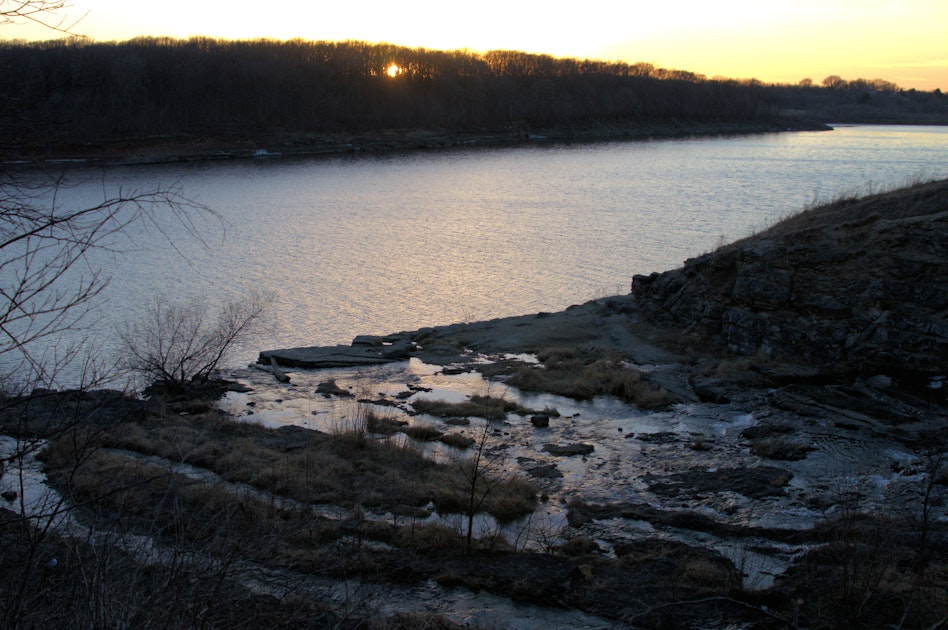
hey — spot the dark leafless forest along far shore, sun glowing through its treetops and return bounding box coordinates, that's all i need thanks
[0,37,948,156]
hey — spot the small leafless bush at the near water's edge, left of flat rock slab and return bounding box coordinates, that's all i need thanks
[120,291,272,388]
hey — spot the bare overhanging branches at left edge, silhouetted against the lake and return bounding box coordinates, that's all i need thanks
[0,173,220,386]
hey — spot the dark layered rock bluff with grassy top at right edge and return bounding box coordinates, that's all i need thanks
[632,180,948,379]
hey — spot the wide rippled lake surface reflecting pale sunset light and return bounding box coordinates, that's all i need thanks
[7,127,948,380]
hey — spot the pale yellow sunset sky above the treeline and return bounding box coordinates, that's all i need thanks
[0,0,948,91]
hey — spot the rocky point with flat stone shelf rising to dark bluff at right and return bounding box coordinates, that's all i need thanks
[259,175,948,433]
